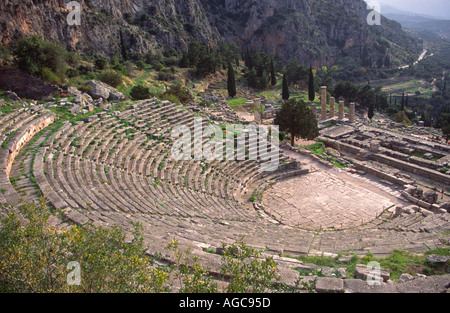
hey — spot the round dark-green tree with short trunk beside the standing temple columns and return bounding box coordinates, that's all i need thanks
[274,99,319,146]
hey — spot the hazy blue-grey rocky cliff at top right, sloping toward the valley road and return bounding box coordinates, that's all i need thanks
[201,0,417,66]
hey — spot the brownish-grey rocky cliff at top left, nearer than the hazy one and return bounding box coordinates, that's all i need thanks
[0,0,220,56]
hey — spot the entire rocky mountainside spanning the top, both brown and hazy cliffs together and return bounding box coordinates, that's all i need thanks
[0,0,418,66]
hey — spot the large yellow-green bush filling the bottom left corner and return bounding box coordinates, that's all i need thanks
[0,202,168,293]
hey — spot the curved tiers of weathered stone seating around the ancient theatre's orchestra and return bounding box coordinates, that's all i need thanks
[0,99,450,278]
